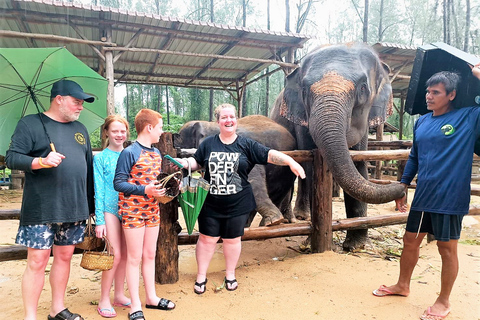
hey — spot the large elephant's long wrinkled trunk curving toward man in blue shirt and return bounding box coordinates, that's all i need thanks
[309,72,404,203]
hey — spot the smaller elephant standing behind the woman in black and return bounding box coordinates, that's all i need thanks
[173,115,296,227]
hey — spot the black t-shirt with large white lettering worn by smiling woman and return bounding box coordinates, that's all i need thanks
[193,134,270,218]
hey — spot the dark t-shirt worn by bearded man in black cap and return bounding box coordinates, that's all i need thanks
[6,113,95,225]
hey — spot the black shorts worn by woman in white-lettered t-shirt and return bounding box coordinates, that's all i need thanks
[198,213,250,239]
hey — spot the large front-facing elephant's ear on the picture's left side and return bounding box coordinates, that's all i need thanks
[280,68,308,127]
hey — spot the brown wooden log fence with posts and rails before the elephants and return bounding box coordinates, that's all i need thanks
[0,134,480,284]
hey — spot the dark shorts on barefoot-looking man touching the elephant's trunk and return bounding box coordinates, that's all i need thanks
[406,210,464,241]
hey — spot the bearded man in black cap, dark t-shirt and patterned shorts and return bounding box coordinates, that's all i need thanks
[6,80,95,320]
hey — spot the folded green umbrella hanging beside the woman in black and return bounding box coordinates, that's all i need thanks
[178,167,210,234]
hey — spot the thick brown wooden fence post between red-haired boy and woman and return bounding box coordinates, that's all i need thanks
[155,132,181,284]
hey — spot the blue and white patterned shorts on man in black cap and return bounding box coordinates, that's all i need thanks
[15,221,86,250]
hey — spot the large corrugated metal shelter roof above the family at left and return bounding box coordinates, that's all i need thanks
[0,0,310,88]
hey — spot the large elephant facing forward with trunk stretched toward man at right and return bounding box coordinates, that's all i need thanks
[270,44,404,250]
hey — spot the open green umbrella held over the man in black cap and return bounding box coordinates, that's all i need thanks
[0,48,108,155]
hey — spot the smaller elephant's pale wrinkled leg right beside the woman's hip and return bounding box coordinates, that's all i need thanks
[248,165,285,226]
